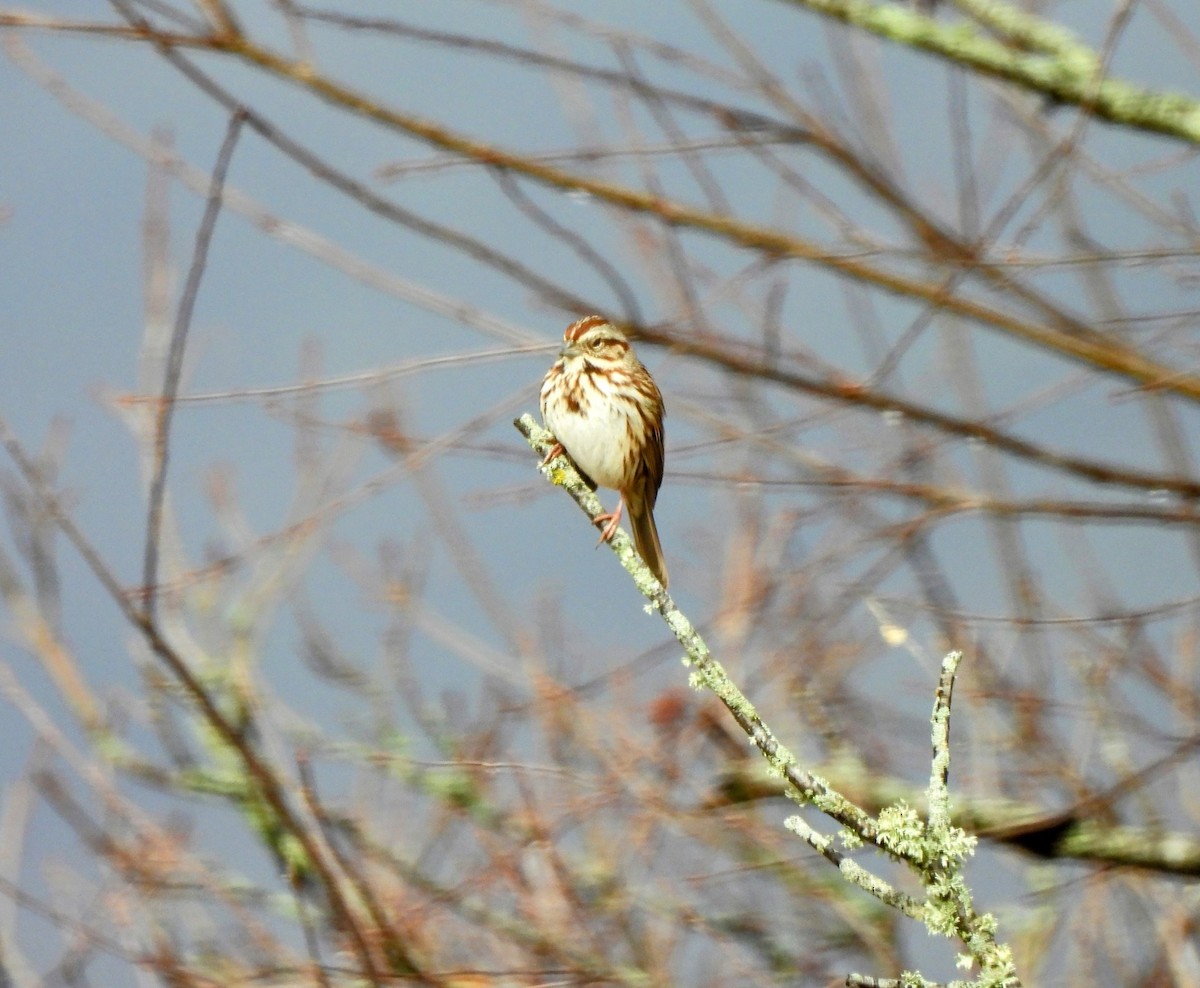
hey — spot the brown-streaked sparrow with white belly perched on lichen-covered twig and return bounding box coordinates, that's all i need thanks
[541,316,667,587]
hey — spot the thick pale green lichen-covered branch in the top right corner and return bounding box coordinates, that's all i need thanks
[768,0,1200,143]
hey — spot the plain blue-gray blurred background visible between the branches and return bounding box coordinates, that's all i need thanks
[0,0,1200,984]
